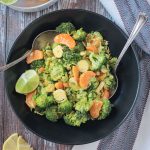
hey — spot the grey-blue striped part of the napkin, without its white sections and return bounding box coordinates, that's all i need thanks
[98,0,150,150]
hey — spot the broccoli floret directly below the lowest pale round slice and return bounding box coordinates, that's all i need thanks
[58,100,73,113]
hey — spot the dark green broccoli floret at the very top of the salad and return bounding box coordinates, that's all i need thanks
[56,22,75,34]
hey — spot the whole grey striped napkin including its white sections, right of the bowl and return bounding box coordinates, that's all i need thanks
[72,0,150,150]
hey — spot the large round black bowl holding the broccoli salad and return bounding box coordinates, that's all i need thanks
[5,10,140,144]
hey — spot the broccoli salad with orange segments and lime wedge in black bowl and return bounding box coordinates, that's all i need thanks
[15,22,117,127]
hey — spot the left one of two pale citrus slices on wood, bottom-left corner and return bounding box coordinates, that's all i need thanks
[3,133,18,150]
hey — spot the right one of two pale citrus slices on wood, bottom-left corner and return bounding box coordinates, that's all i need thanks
[17,136,33,150]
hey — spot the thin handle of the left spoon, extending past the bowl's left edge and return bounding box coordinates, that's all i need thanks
[0,50,32,72]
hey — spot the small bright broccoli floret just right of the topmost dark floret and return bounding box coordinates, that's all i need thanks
[73,28,86,41]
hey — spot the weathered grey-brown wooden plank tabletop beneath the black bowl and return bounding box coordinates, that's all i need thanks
[0,0,110,150]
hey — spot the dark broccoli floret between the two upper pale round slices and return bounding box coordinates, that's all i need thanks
[63,50,81,68]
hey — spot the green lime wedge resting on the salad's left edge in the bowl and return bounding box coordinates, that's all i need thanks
[15,70,39,94]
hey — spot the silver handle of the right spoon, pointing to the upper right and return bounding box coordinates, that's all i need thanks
[115,12,148,71]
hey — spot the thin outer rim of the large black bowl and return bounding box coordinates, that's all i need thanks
[4,9,141,145]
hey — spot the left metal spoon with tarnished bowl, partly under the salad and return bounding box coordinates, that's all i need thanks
[0,30,58,72]
